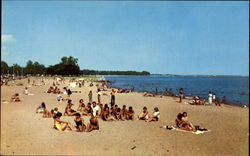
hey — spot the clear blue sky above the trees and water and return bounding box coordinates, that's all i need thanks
[1,1,249,75]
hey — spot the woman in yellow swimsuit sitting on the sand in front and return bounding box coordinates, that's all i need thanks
[53,112,72,131]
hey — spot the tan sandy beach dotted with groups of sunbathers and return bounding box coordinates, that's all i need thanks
[1,79,249,156]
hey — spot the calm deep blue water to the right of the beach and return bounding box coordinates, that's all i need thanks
[105,76,249,106]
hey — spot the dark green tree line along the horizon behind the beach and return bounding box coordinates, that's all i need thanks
[1,56,150,76]
